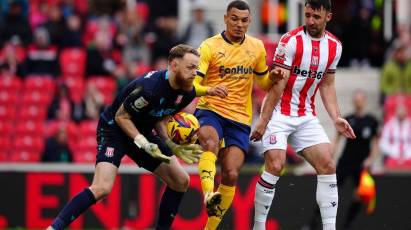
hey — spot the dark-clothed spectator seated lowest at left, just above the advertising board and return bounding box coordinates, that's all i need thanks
[41,128,73,163]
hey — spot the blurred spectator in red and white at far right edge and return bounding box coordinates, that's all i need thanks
[380,104,411,166]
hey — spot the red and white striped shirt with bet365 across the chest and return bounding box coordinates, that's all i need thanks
[274,26,342,116]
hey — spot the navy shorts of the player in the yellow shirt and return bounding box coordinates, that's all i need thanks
[194,109,251,153]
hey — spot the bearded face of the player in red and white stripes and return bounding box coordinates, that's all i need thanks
[304,5,332,38]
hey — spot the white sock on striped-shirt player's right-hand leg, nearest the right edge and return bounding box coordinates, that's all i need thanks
[316,174,338,230]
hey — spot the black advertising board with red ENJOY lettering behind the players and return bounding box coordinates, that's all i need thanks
[0,164,411,230]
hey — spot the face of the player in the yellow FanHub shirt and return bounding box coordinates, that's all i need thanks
[224,8,251,42]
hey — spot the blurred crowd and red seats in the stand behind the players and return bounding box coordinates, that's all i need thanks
[0,0,411,173]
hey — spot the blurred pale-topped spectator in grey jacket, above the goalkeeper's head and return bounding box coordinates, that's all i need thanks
[181,0,214,48]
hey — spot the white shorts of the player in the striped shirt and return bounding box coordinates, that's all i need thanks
[262,113,330,153]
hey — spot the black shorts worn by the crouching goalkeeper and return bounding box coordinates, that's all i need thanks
[96,118,173,172]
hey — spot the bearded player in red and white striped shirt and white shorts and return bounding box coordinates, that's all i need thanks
[251,0,355,230]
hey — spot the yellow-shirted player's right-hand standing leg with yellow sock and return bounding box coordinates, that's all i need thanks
[205,145,244,230]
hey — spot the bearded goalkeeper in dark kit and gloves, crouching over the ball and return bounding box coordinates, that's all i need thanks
[49,45,202,230]
